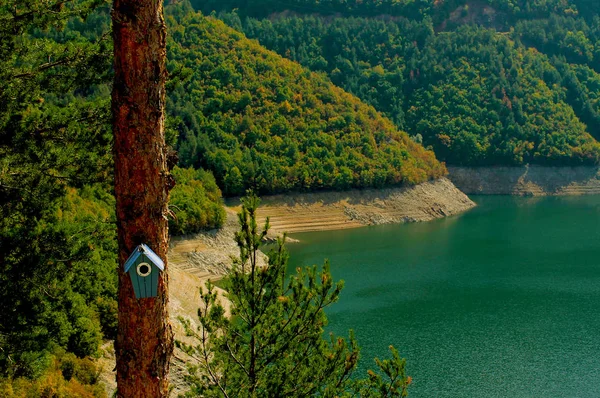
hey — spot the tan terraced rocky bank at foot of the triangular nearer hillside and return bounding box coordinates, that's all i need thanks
[248,178,475,234]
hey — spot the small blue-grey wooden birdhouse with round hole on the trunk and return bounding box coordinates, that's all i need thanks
[125,243,165,299]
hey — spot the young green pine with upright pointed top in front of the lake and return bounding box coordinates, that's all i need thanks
[177,195,410,398]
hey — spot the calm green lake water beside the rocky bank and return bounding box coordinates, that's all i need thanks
[288,196,600,398]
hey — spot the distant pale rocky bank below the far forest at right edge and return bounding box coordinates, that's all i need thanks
[448,166,600,196]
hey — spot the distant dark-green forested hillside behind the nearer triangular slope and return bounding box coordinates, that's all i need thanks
[205,0,600,166]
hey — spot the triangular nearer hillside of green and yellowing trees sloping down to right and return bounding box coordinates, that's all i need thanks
[168,4,445,195]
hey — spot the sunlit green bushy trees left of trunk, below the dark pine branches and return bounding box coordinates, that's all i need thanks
[0,187,117,377]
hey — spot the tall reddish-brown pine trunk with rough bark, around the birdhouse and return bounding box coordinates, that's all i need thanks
[112,0,173,397]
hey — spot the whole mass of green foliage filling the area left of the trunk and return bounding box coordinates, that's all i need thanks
[0,0,116,377]
